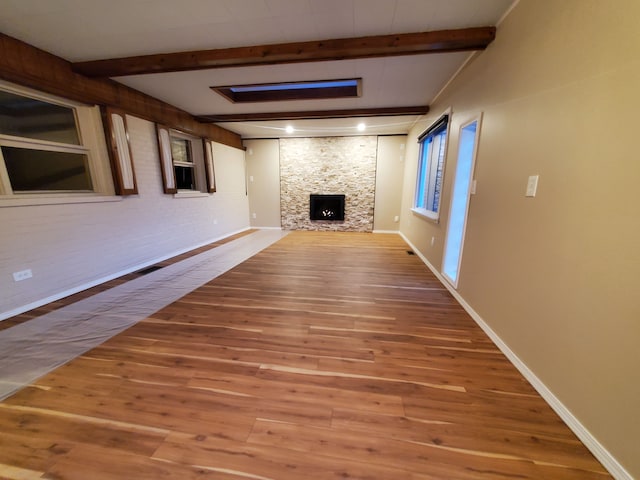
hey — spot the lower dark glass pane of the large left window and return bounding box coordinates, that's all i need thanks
[2,147,92,192]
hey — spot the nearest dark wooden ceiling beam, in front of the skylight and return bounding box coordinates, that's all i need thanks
[72,27,496,77]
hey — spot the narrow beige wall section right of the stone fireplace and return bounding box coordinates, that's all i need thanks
[373,135,407,232]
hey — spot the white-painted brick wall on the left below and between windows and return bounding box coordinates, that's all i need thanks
[0,116,249,319]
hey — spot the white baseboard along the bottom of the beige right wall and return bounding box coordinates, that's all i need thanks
[399,232,633,480]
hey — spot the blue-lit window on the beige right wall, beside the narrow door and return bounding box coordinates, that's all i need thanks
[414,114,449,220]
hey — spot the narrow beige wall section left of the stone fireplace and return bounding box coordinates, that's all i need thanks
[243,139,280,228]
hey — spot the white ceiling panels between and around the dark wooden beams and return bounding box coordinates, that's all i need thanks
[0,0,514,138]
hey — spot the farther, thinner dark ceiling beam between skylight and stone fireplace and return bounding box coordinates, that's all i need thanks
[198,105,429,123]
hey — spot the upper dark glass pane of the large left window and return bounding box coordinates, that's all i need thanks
[0,91,80,145]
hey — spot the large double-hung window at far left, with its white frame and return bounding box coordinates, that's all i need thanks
[0,83,113,200]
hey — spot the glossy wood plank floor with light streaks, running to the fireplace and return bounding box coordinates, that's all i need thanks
[0,232,611,480]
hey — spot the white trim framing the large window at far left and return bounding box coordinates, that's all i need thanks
[0,81,115,207]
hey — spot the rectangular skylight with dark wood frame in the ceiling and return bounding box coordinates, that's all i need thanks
[211,78,362,103]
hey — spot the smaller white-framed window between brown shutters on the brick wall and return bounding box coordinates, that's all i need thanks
[157,125,215,197]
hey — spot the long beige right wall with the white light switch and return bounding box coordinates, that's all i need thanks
[401,0,640,478]
